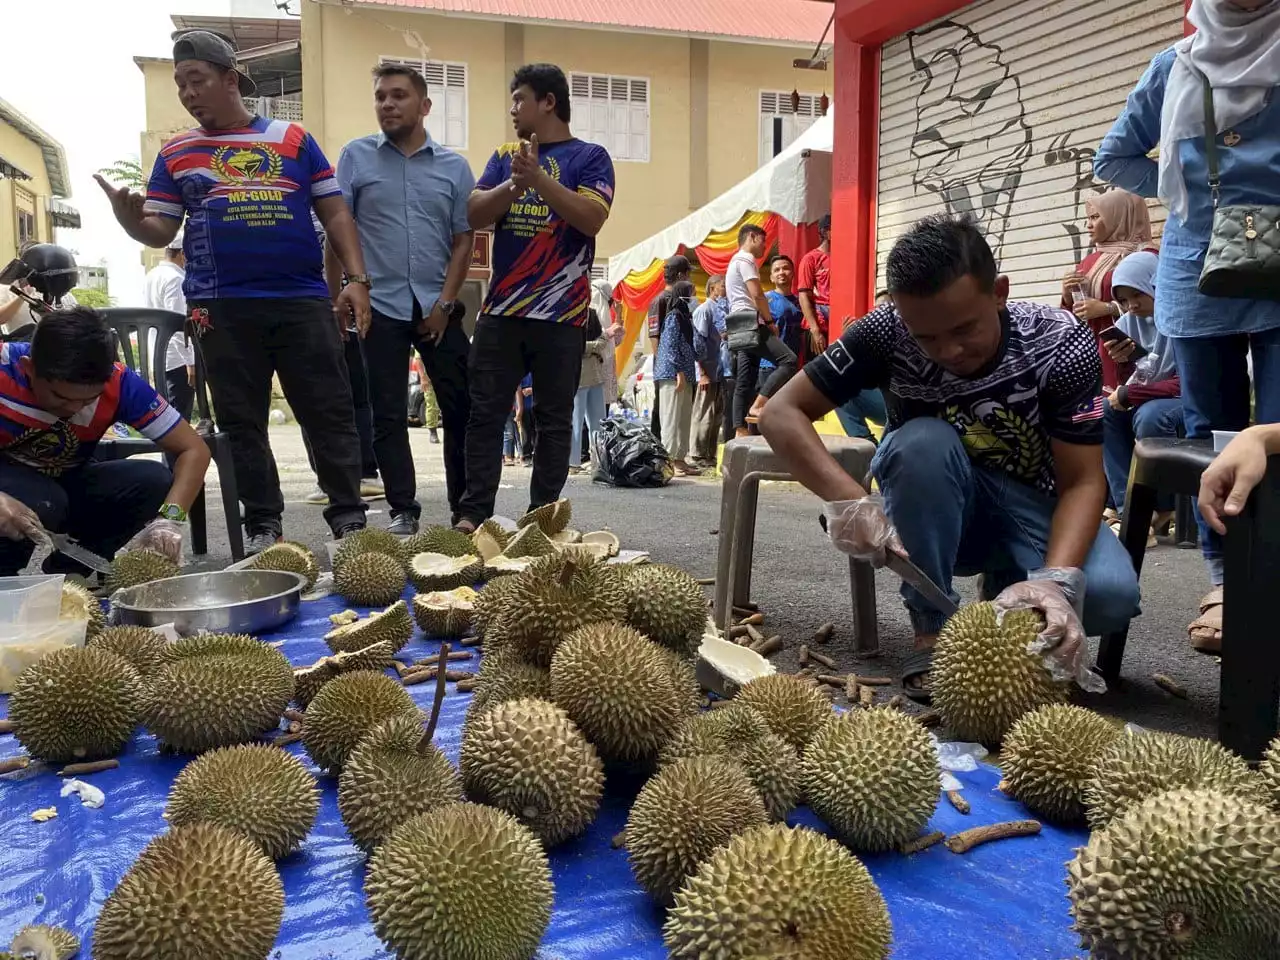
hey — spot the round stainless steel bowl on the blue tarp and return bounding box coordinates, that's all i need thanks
[111,570,306,636]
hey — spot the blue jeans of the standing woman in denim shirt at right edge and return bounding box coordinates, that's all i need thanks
[1174,329,1280,584]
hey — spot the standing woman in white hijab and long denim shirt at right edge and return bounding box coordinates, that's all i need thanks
[1094,0,1280,652]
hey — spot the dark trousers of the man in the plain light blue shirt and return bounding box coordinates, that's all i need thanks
[365,303,473,520]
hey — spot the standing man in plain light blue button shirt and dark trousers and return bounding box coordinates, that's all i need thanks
[328,64,475,536]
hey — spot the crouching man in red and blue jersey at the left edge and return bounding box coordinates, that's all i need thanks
[0,307,209,576]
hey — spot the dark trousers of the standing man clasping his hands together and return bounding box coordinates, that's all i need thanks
[460,316,584,524]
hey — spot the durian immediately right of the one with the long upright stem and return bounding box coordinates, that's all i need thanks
[460,699,604,849]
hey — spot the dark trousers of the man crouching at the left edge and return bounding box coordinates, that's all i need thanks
[0,460,172,577]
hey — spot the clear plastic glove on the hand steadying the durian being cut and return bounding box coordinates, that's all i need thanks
[996,567,1107,694]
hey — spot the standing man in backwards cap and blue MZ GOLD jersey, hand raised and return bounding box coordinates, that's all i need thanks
[99,31,370,553]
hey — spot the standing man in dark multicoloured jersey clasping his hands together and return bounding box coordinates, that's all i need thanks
[456,64,613,531]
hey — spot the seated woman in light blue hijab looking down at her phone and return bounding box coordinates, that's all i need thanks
[1102,251,1183,545]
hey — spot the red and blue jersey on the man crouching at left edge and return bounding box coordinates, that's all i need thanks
[0,343,182,476]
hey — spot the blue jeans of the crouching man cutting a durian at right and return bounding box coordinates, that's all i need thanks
[872,417,1139,636]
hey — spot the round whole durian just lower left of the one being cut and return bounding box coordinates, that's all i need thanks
[800,708,942,852]
